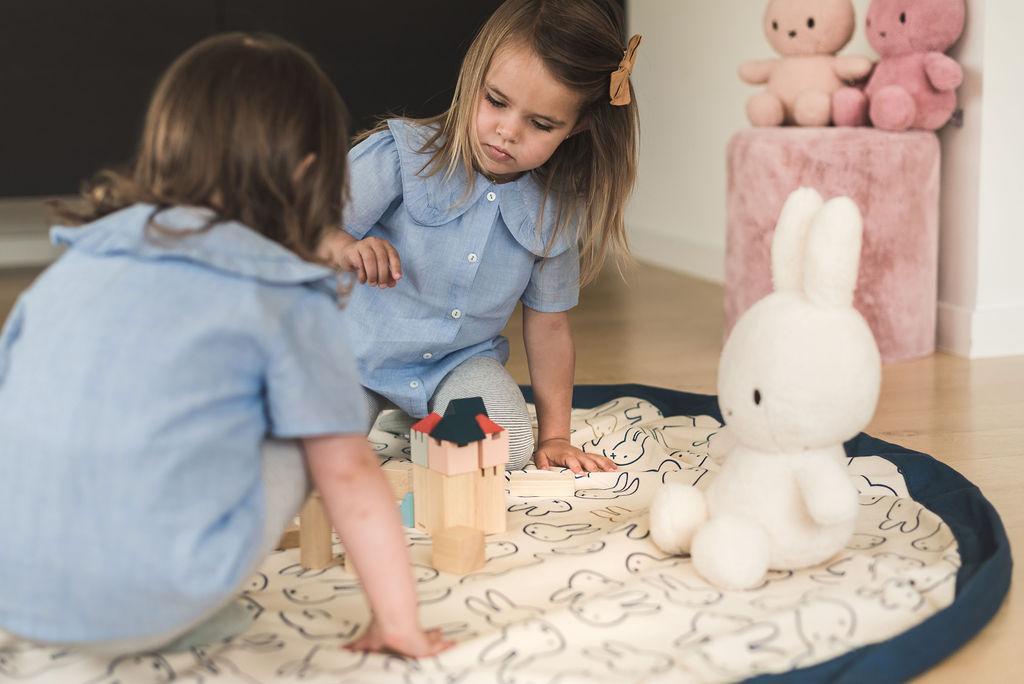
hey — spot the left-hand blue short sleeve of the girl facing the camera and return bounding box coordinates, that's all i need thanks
[343,130,401,240]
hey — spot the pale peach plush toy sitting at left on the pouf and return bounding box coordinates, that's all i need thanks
[739,0,871,126]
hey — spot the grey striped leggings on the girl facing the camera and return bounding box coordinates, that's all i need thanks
[366,356,534,470]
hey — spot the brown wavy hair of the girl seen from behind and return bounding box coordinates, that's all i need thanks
[53,33,348,262]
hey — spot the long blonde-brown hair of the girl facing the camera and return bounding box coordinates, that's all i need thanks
[357,0,639,285]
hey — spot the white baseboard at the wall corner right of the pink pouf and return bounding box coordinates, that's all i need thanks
[938,302,1024,358]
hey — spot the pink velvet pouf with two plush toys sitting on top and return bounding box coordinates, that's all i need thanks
[725,127,940,362]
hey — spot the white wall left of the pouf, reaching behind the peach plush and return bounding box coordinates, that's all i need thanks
[627,0,874,283]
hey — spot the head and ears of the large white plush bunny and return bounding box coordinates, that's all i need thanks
[718,188,881,452]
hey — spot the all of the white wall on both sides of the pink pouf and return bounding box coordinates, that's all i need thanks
[627,0,1024,356]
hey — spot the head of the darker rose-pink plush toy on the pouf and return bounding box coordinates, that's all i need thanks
[867,0,967,57]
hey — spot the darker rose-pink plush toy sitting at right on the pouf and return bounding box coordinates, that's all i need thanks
[834,0,967,131]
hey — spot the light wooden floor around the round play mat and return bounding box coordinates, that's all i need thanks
[0,260,1024,684]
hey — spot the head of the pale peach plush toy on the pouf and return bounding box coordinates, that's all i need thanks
[764,0,854,56]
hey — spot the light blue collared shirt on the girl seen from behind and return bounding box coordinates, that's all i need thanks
[0,205,366,642]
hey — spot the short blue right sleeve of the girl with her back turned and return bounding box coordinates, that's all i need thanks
[266,290,369,438]
